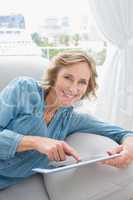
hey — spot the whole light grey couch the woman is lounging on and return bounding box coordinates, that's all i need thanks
[0,56,133,200]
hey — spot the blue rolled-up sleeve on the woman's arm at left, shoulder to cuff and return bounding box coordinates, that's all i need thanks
[0,77,39,160]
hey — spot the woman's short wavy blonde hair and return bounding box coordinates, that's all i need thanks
[41,50,98,99]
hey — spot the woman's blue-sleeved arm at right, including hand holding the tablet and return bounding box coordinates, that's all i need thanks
[69,113,133,167]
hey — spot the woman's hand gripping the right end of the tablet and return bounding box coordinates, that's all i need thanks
[102,137,133,168]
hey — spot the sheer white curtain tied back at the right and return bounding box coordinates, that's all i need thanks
[88,0,133,129]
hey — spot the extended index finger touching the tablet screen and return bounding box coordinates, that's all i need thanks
[63,142,81,161]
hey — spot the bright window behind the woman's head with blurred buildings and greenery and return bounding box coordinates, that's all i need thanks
[0,0,107,65]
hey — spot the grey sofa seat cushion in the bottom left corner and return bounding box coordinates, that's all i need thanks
[0,174,48,200]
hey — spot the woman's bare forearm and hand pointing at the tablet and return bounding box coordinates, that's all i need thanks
[16,136,80,161]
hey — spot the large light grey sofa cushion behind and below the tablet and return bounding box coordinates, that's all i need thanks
[44,133,133,200]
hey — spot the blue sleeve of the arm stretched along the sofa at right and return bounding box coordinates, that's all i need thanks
[68,112,133,144]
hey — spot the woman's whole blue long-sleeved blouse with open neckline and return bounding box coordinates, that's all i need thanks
[0,77,133,189]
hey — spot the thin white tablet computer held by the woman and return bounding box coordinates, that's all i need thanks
[32,153,122,174]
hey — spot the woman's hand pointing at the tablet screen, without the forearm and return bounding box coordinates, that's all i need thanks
[35,137,80,161]
